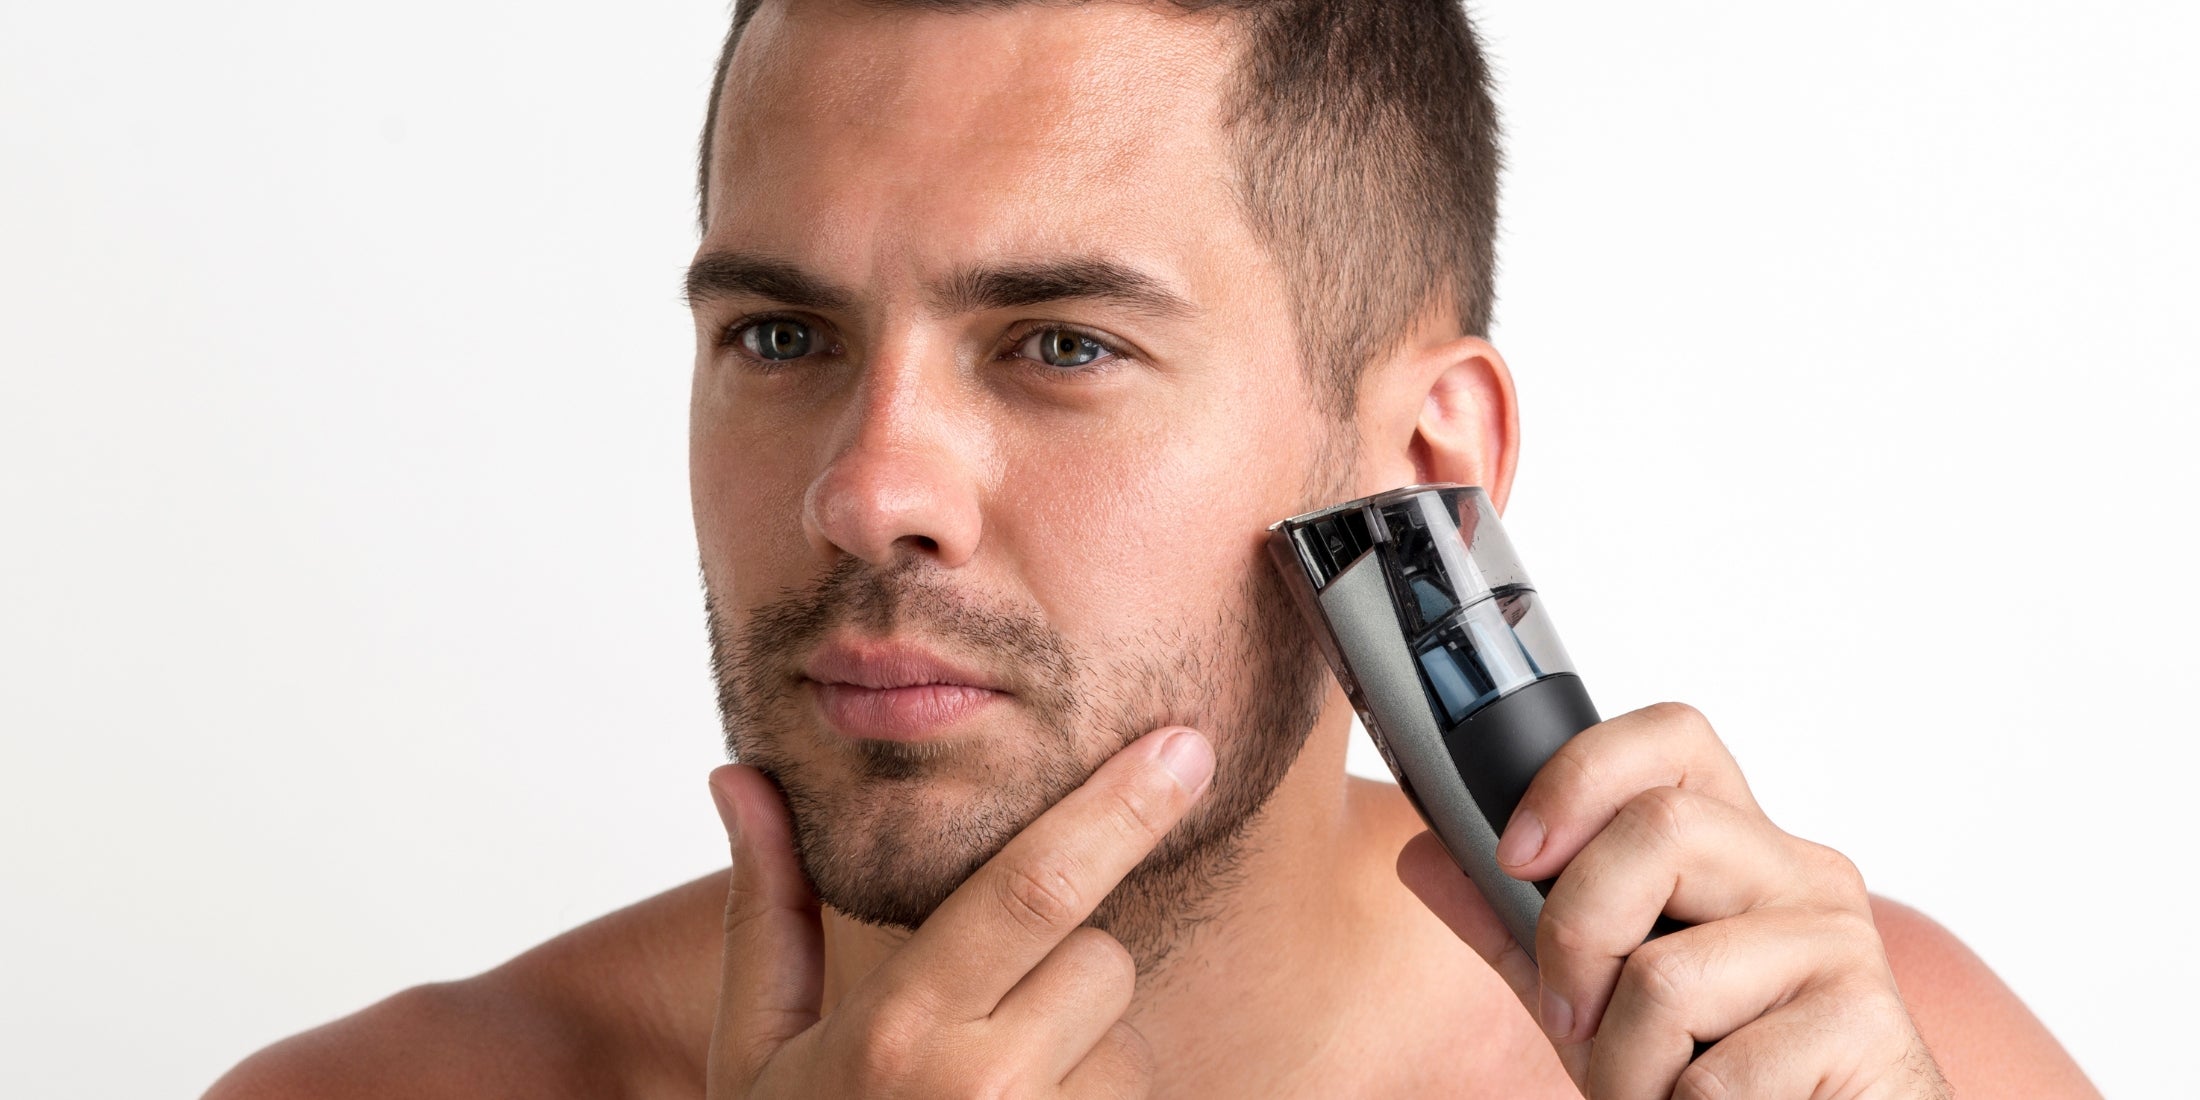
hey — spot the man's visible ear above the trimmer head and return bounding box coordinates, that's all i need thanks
[1362,337,1520,513]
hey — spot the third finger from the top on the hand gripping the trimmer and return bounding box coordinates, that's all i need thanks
[1586,909,1907,1100]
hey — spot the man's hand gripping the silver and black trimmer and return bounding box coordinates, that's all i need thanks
[1397,704,1947,1100]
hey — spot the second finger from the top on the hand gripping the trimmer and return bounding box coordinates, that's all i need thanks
[1536,788,1808,1038]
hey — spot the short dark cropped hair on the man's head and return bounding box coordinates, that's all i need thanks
[697,0,1498,418]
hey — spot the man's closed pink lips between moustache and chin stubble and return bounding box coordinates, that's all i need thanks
[803,640,1008,741]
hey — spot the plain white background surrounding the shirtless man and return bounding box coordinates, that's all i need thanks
[0,0,2200,1098]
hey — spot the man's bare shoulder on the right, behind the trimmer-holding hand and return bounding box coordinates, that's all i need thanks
[1872,893,2101,1098]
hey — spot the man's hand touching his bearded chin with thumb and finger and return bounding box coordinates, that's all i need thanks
[708,728,1214,1100]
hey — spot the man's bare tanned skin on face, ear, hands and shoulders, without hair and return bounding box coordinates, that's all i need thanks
[209,2,2094,1098]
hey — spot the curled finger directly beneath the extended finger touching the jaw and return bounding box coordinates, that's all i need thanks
[992,928,1137,1082]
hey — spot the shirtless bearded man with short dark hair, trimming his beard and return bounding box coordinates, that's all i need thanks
[213,0,2092,1098]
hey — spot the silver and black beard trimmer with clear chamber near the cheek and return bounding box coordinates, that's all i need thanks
[1269,484,1663,957]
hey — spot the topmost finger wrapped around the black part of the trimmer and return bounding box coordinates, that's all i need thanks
[1496,702,1762,882]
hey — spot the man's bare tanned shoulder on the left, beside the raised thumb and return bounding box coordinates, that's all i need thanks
[207,871,726,1100]
